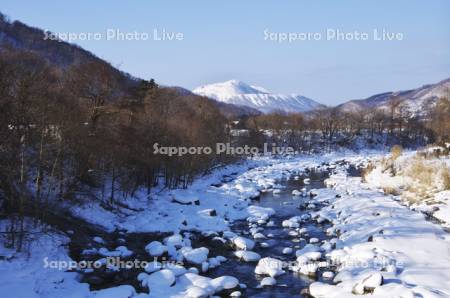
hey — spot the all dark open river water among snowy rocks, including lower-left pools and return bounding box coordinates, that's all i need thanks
[71,166,338,297]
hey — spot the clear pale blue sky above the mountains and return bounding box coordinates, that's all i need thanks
[0,0,450,105]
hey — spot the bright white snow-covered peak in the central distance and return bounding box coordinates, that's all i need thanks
[192,80,324,113]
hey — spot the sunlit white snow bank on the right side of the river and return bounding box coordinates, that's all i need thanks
[310,156,450,297]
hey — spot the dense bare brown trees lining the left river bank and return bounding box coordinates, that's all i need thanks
[0,48,230,249]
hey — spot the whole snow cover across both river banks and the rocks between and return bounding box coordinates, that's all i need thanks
[0,152,450,298]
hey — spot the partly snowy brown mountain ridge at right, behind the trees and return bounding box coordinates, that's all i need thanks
[338,79,450,116]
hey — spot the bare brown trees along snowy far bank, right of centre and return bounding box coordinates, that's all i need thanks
[244,91,450,152]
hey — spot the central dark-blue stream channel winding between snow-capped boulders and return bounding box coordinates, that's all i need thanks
[207,170,329,297]
